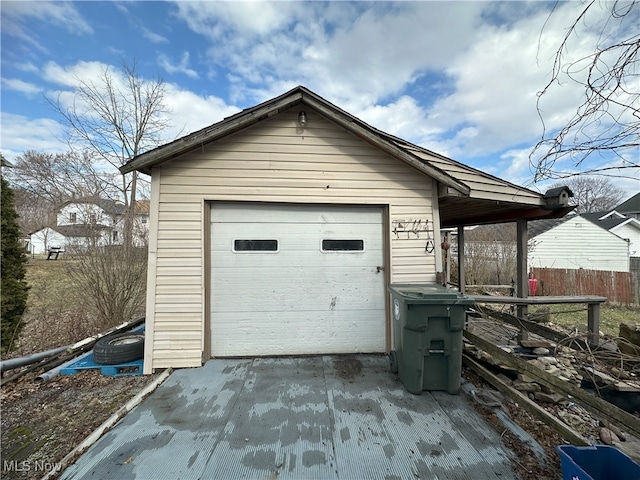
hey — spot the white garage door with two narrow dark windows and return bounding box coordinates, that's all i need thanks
[211,203,385,356]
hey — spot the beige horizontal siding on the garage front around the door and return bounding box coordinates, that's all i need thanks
[145,109,440,371]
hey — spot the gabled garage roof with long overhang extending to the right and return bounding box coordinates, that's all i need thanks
[120,86,572,227]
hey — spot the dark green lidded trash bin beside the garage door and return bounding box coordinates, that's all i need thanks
[389,284,473,395]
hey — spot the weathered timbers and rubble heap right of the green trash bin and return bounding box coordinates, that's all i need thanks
[464,315,640,462]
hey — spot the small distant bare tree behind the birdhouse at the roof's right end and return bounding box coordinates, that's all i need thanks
[551,176,625,214]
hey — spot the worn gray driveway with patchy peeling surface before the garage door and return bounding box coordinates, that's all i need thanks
[61,355,515,480]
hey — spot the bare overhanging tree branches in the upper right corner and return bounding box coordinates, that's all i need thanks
[529,0,640,181]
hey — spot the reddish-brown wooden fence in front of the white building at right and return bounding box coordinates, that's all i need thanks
[531,262,640,305]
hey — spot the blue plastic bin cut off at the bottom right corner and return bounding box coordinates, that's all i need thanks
[556,445,640,480]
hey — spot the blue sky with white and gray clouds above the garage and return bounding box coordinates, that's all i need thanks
[0,1,640,196]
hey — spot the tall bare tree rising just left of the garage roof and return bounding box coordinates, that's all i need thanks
[51,63,169,245]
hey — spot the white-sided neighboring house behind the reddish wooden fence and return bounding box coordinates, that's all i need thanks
[529,211,640,272]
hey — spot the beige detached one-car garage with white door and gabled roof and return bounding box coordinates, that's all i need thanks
[121,87,565,373]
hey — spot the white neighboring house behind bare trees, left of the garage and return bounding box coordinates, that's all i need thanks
[30,197,149,254]
